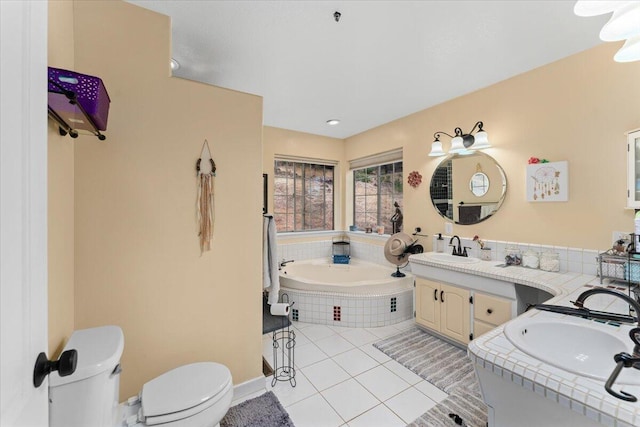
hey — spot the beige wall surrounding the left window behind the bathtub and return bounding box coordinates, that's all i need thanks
[262,126,348,230]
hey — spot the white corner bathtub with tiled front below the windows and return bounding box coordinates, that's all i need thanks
[280,259,414,328]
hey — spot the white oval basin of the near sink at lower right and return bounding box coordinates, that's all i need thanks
[504,318,640,385]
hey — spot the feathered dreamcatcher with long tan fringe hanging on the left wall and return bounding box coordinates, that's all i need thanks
[196,139,216,254]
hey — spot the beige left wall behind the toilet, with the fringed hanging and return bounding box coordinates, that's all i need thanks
[50,1,262,399]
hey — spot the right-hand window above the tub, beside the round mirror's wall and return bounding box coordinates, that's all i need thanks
[353,162,402,234]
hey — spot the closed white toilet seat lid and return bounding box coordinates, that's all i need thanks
[141,362,231,417]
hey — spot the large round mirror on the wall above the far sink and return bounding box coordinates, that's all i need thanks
[429,151,507,225]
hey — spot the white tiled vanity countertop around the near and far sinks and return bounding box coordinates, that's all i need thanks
[412,254,640,427]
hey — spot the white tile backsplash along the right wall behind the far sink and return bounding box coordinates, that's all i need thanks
[432,235,603,276]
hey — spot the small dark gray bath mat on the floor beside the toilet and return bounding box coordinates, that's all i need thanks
[220,391,295,427]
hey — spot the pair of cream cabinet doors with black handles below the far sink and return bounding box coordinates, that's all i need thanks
[416,277,471,344]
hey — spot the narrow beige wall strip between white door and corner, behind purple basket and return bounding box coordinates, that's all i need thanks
[47,0,74,358]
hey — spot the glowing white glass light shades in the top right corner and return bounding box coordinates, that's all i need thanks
[573,0,640,62]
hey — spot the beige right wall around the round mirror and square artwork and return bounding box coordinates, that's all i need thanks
[346,43,640,249]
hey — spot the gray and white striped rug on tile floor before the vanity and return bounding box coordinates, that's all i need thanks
[373,327,487,427]
